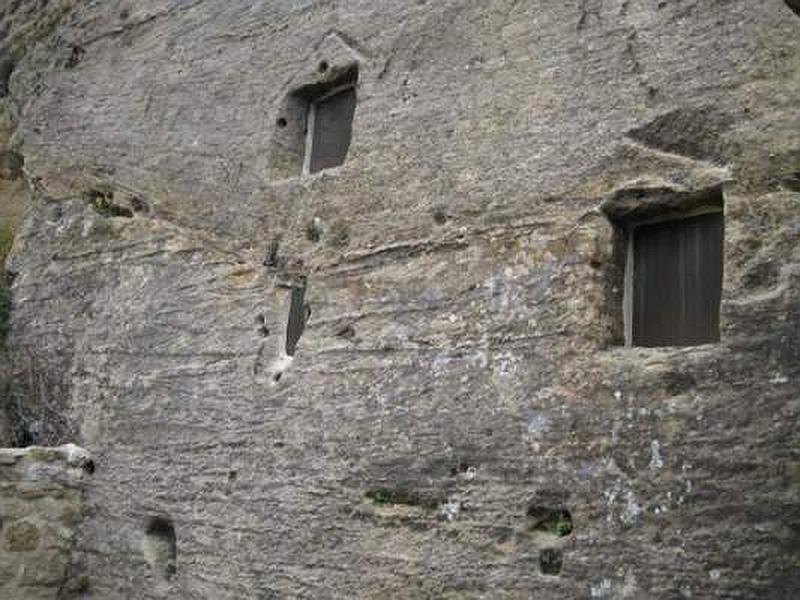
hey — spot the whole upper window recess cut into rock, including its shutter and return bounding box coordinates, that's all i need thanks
[270,61,358,178]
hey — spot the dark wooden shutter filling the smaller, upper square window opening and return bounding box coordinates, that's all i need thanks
[308,87,356,173]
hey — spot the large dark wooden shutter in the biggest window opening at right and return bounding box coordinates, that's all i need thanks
[631,213,724,346]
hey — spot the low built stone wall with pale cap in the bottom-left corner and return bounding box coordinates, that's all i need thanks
[0,445,94,600]
